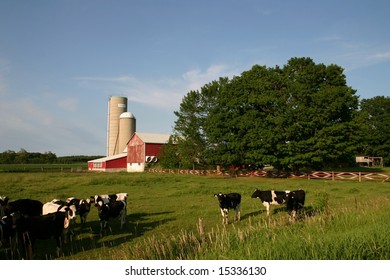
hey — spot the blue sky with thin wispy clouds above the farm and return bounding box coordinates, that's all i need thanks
[0,0,390,156]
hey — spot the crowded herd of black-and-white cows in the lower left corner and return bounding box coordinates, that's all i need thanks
[0,193,128,259]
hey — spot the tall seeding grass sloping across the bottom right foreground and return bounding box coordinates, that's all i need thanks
[124,197,390,260]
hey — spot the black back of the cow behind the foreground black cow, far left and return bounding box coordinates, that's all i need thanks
[3,198,43,216]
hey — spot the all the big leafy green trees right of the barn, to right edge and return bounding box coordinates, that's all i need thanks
[160,58,390,171]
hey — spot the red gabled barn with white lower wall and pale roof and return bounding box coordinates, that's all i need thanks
[127,132,170,172]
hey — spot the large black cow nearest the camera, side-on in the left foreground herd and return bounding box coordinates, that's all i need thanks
[16,209,70,259]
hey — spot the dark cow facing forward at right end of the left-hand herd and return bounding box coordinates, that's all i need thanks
[97,200,127,235]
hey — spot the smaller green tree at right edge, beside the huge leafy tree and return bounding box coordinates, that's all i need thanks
[356,96,390,166]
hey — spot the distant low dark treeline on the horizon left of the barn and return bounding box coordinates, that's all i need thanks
[0,149,102,164]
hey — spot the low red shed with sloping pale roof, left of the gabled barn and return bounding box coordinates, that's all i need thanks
[88,152,127,172]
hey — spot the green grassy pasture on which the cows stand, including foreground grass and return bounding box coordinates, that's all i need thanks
[0,172,390,260]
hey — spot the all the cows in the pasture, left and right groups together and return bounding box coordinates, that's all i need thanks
[0,189,305,258]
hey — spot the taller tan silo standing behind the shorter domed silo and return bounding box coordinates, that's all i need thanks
[107,96,127,156]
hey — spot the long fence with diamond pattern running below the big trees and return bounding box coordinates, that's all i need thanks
[145,168,390,182]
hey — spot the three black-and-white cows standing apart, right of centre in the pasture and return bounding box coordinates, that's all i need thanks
[214,189,306,224]
